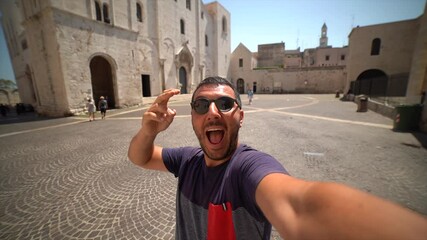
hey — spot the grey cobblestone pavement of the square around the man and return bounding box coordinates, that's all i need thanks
[0,95,427,239]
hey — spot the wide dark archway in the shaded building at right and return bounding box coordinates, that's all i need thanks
[355,69,388,96]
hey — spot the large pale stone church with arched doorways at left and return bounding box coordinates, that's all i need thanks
[0,0,230,116]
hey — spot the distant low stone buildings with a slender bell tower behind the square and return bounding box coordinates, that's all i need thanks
[230,24,348,93]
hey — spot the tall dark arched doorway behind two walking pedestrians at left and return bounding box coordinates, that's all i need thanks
[90,56,116,108]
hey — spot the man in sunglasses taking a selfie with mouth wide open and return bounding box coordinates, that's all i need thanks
[128,77,427,240]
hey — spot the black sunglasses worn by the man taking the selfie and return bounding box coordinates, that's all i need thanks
[190,96,241,114]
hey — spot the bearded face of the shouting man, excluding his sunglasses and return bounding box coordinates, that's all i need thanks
[191,84,243,166]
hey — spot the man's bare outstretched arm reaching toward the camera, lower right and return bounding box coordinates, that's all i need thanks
[256,174,427,240]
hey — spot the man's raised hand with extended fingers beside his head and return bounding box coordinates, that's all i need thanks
[142,89,180,136]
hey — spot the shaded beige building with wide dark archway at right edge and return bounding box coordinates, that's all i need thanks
[345,5,427,132]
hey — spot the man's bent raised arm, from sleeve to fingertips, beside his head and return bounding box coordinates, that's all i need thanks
[128,89,179,171]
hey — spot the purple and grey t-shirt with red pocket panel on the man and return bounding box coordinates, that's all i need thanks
[162,145,288,239]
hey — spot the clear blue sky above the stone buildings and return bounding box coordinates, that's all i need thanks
[0,0,426,80]
